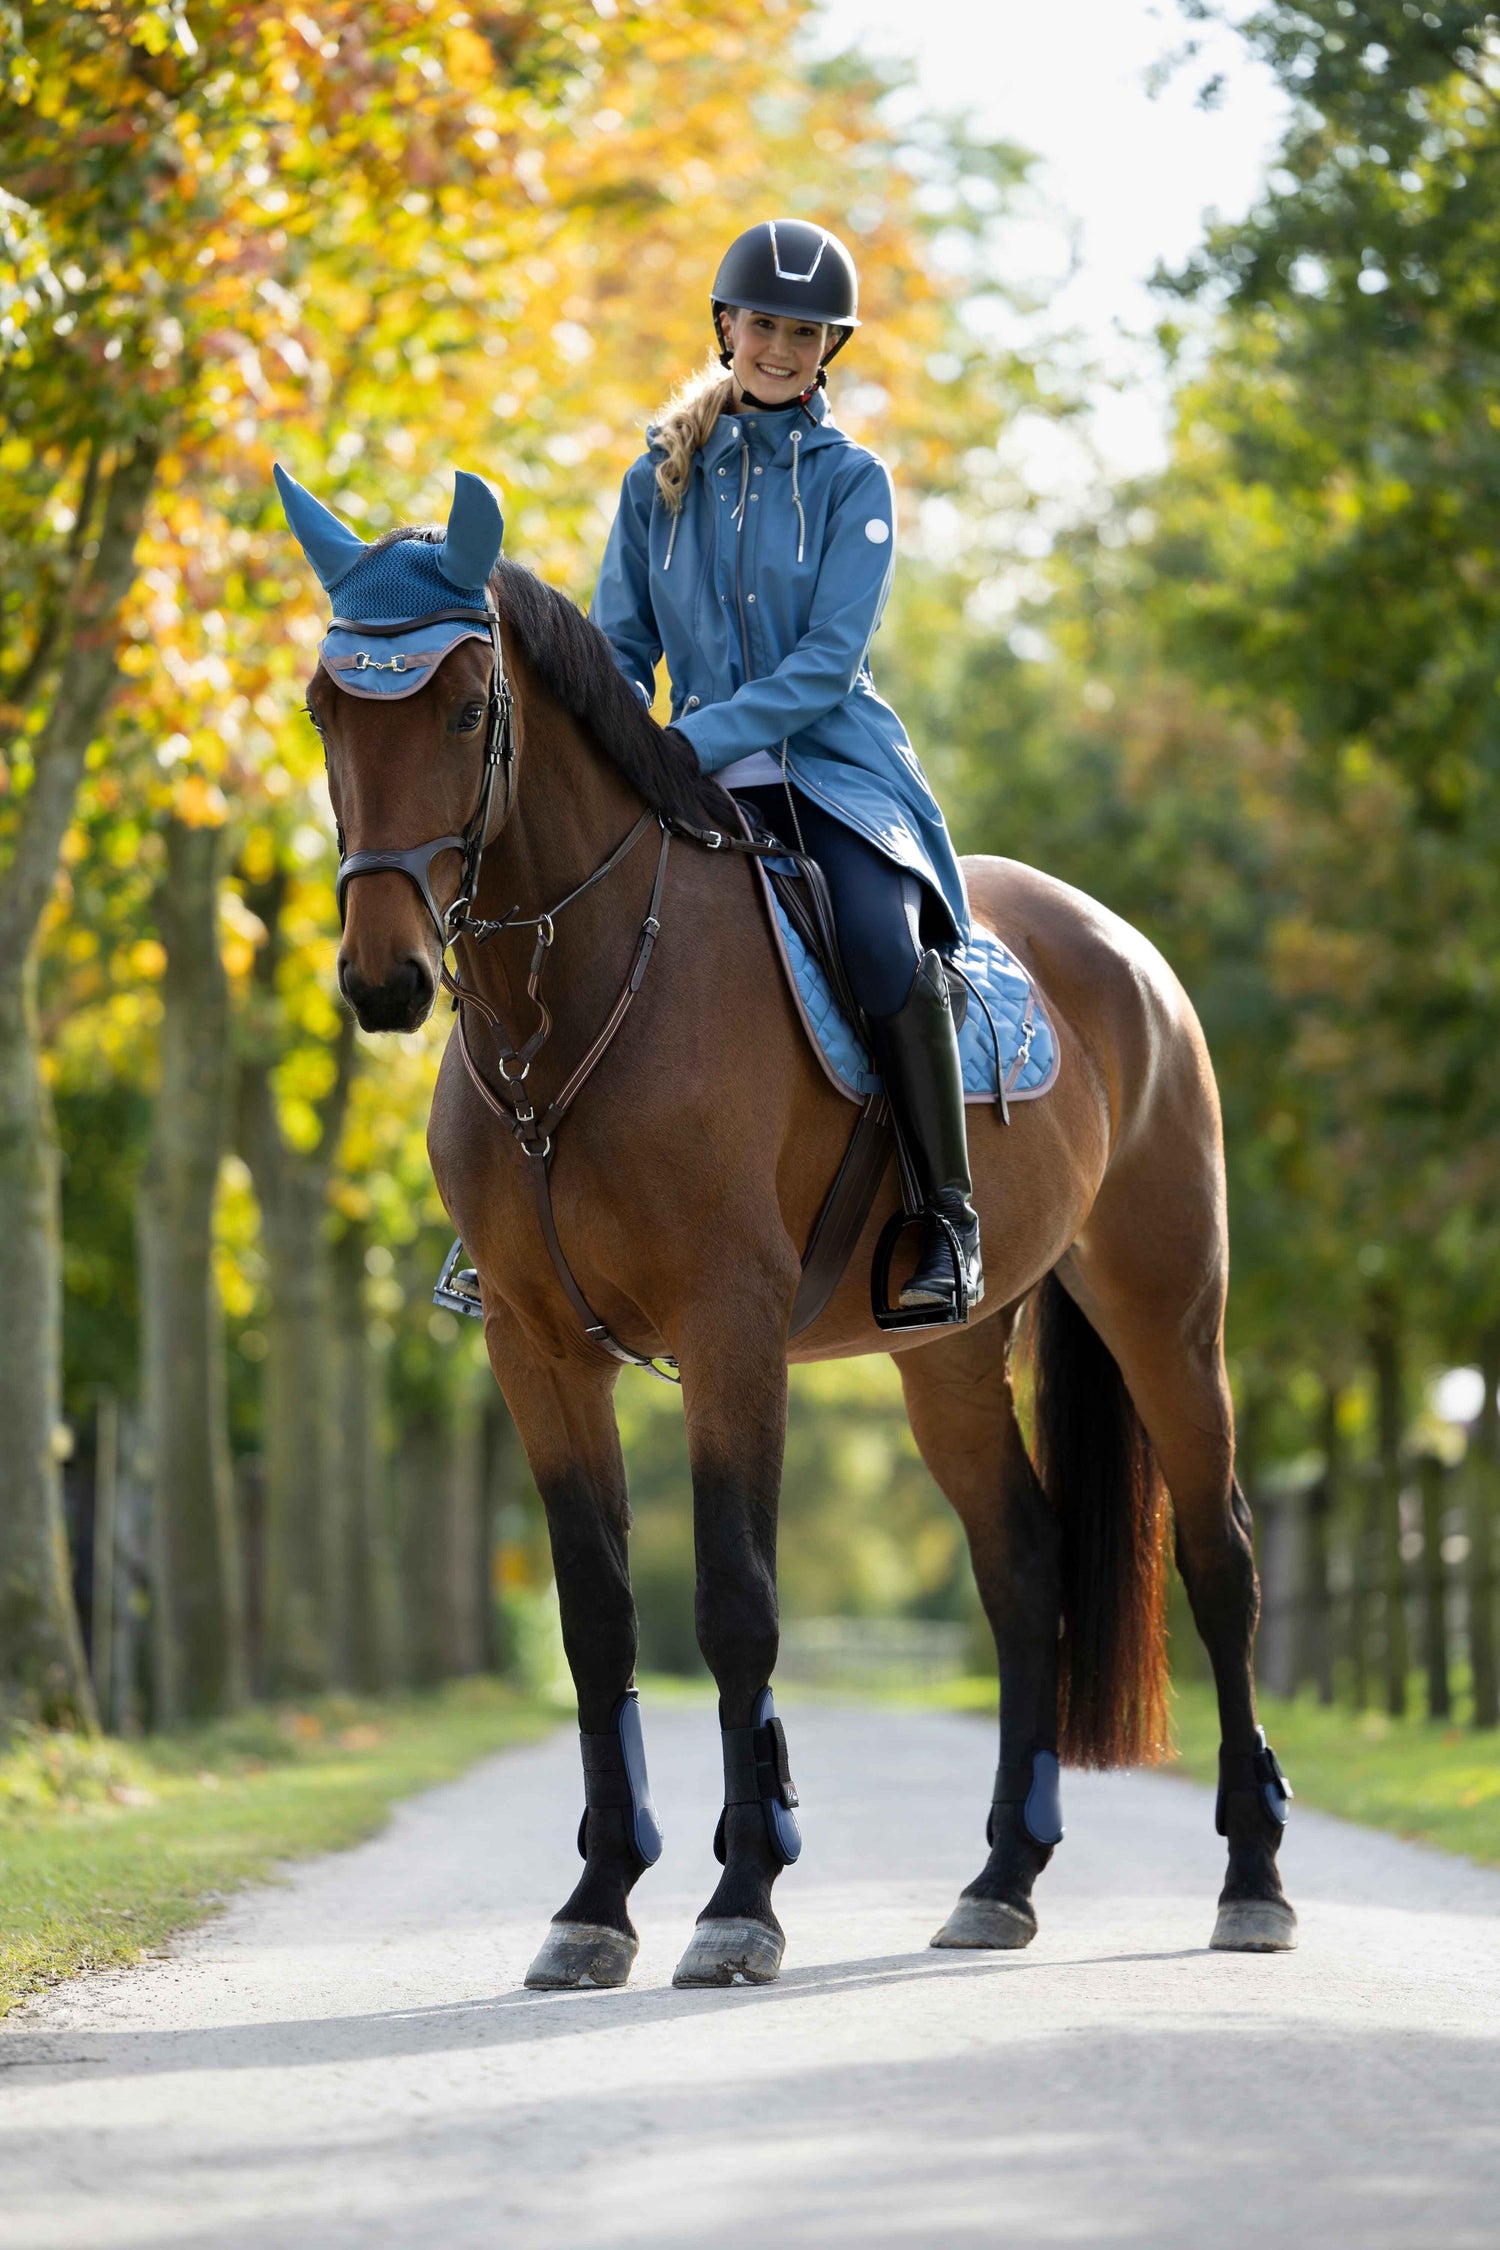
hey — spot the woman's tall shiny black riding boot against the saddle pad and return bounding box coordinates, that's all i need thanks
[873,952,985,1316]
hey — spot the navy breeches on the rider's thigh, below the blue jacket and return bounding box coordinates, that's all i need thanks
[735,783,922,1015]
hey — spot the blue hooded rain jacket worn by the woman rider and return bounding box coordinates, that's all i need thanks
[589,392,969,950]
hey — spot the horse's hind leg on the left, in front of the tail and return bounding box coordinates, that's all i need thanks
[897,1312,1061,1949]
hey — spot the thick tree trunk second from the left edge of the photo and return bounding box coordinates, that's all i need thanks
[137,821,245,1726]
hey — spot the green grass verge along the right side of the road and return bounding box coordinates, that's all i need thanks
[900,1679,1500,1868]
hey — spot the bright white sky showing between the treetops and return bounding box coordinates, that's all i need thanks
[821,0,1284,497]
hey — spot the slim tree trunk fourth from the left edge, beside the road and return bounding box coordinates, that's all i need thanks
[328,1224,394,1694]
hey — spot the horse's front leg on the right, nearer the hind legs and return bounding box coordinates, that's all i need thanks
[672,1280,801,1985]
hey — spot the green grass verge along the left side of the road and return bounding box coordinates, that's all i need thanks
[0,1679,555,2016]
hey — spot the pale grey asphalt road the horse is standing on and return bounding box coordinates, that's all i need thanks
[0,1708,1500,2250]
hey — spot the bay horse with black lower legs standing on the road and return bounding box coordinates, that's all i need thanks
[308,529,1295,1987]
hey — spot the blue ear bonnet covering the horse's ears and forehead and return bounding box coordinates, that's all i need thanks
[277,466,504,698]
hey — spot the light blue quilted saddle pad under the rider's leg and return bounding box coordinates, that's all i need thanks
[765,864,1057,1103]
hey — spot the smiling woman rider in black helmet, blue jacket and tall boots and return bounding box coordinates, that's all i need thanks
[591,218,983,1321]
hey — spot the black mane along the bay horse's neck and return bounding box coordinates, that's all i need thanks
[373,524,735,828]
